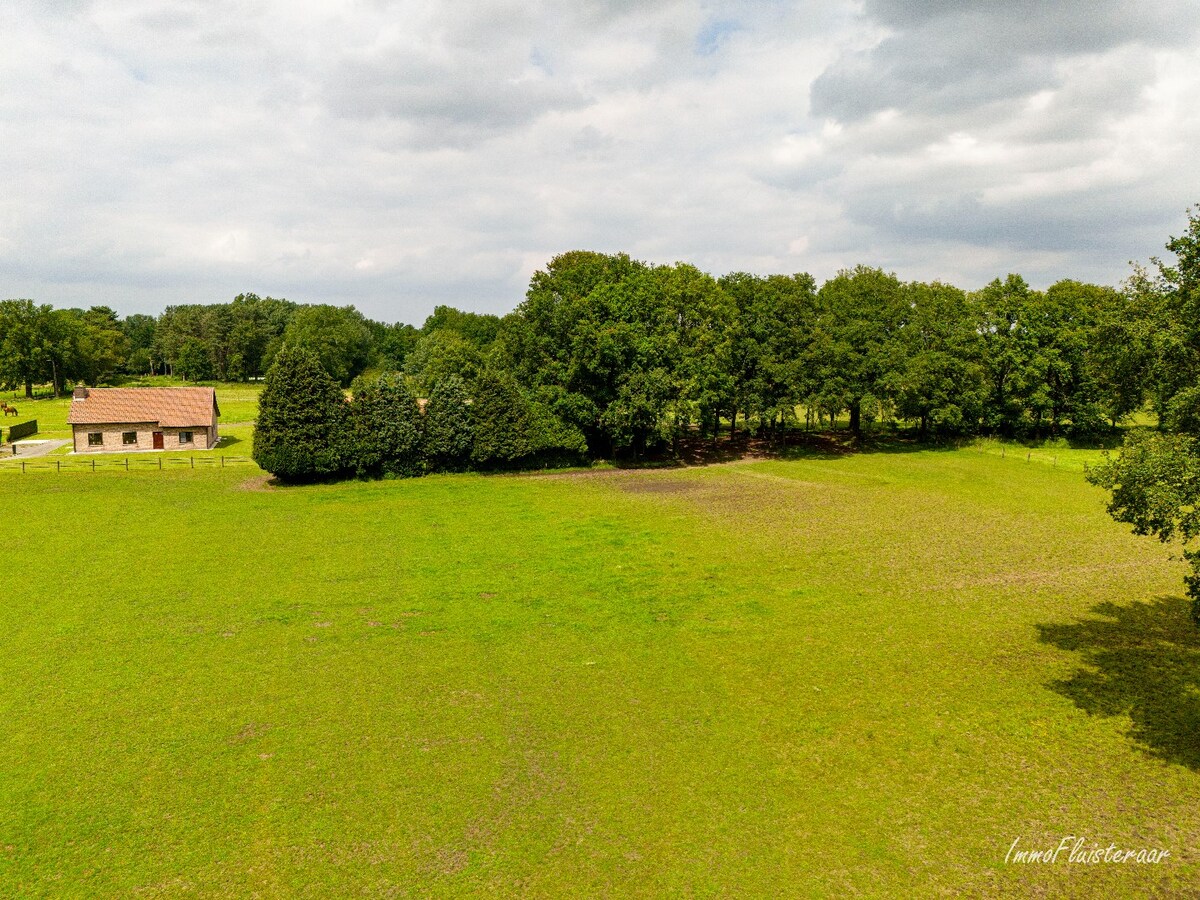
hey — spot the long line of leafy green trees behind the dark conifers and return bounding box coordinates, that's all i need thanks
[0,251,1180,448]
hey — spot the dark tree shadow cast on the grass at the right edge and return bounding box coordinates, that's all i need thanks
[1038,596,1200,770]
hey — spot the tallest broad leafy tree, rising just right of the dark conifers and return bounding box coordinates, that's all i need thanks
[498,252,733,455]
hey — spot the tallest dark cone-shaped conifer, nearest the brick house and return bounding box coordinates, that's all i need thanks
[254,346,352,481]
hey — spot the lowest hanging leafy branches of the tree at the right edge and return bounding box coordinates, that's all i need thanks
[1087,433,1200,624]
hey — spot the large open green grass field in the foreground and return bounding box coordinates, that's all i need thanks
[0,448,1200,898]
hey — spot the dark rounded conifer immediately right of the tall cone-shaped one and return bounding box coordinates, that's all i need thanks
[348,374,425,478]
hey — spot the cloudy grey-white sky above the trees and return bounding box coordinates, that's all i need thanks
[0,0,1200,323]
